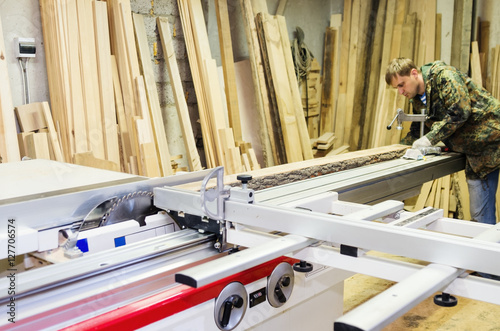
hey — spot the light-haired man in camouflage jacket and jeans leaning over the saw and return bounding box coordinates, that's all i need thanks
[385,58,500,224]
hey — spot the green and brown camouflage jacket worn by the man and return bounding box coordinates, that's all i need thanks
[403,61,500,179]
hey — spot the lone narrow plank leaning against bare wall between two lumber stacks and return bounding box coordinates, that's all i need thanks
[156,17,202,171]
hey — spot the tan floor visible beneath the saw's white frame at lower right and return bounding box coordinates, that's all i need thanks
[344,253,500,331]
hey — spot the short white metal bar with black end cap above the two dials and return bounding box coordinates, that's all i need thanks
[175,235,316,287]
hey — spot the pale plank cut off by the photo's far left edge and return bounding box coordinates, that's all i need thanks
[0,13,21,162]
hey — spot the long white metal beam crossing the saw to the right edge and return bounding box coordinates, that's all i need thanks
[225,200,500,275]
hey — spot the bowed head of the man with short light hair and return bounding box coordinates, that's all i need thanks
[385,57,425,99]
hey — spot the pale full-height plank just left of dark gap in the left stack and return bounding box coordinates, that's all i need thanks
[92,1,121,168]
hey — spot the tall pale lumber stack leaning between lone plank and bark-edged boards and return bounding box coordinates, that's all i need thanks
[177,0,260,173]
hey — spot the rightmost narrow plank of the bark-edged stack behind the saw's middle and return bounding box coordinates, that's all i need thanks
[276,16,313,160]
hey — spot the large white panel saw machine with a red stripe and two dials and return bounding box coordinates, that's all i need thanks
[0,153,500,330]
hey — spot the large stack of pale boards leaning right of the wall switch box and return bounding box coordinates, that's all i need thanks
[40,0,201,177]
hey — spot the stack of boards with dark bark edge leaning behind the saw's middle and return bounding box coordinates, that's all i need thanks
[240,0,313,166]
